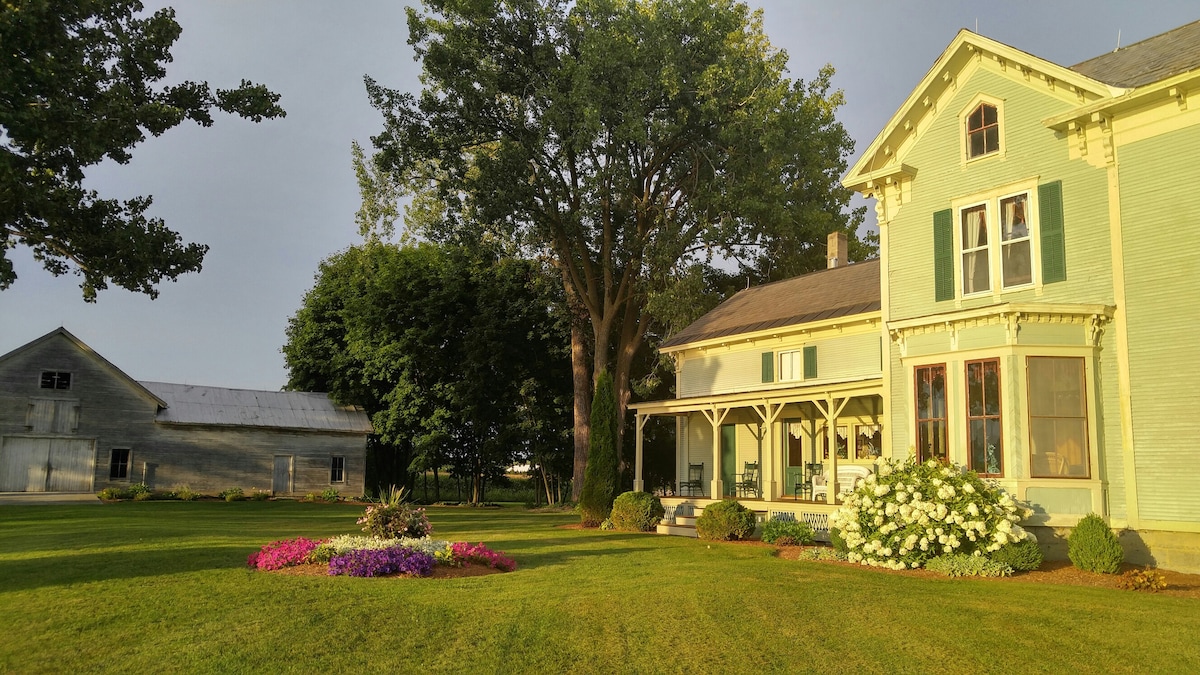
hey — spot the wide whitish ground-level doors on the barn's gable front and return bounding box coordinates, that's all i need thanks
[0,438,96,492]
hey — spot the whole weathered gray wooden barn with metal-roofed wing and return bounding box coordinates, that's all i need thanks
[0,328,371,496]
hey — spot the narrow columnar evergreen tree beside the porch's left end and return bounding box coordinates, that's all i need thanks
[580,370,619,526]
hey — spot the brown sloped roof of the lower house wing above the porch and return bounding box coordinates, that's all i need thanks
[660,259,881,351]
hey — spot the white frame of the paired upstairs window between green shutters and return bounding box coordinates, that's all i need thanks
[950,178,1042,299]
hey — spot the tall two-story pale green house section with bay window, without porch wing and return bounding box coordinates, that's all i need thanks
[845,23,1200,569]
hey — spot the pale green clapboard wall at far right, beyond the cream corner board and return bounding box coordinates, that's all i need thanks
[1120,125,1200,521]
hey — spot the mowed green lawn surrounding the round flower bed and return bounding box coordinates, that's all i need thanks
[0,502,1200,673]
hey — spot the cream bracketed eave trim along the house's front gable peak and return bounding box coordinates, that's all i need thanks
[842,29,1124,190]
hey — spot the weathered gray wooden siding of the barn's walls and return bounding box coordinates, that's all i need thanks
[0,333,366,495]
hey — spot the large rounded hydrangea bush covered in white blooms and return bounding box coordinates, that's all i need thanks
[829,458,1033,569]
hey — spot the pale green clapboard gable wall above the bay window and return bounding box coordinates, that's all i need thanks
[883,61,1112,321]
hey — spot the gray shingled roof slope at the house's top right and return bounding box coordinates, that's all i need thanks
[1070,22,1200,88]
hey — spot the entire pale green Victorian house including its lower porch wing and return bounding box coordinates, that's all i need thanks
[634,22,1200,571]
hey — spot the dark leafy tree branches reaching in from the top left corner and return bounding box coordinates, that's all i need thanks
[0,0,284,301]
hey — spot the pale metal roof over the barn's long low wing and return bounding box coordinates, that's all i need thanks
[140,382,372,434]
